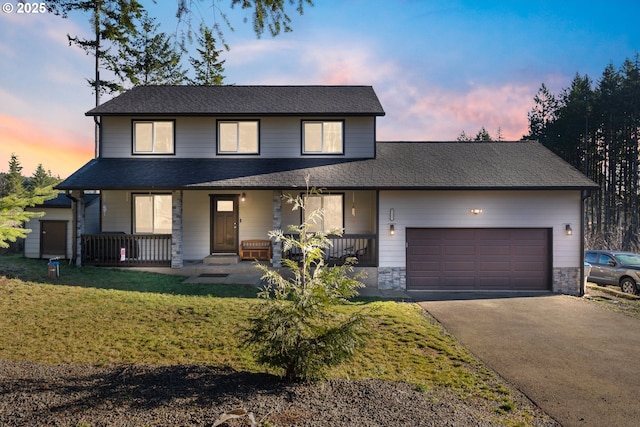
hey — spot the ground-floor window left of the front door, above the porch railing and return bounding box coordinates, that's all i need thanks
[133,194,171,234]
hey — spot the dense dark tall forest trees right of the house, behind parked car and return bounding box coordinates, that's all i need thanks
[525,54,640,251]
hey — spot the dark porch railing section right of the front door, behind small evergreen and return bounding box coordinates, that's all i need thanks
[282,234,378,267]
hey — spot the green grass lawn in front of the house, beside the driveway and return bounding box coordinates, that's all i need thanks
[0,255,527,425]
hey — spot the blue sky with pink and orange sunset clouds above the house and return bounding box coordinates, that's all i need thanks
[0,0,640,178]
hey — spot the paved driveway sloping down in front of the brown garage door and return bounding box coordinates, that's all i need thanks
[412,293,640,427]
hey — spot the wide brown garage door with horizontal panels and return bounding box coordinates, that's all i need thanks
[407,228,551,290]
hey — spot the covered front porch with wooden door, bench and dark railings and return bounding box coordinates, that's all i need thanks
[75,190,378,269]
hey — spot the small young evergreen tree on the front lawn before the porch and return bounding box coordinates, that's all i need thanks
[244,189,365,381]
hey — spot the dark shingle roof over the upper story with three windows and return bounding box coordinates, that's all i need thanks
[86,86,385,116]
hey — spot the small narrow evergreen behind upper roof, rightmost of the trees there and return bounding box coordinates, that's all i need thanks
[189,26,225,86]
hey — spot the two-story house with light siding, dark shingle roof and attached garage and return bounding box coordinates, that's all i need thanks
[58,86,597,294]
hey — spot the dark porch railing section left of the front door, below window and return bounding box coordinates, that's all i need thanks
[82,233,171,267]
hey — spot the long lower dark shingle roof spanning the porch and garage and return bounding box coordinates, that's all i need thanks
[58,142,597,190]
